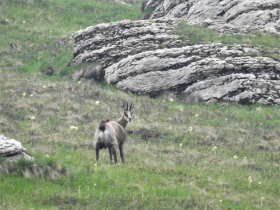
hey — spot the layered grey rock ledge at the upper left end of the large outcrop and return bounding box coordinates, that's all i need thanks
[71,19,182,80]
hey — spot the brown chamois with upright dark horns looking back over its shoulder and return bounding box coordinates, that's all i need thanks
[95,102,134,164]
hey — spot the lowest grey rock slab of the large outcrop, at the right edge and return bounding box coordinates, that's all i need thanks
[184,74,280,105]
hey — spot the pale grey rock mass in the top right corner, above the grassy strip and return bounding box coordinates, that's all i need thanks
[145,0,280,35]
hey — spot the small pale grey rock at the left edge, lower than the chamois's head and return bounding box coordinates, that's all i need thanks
[0,135,34,161]
